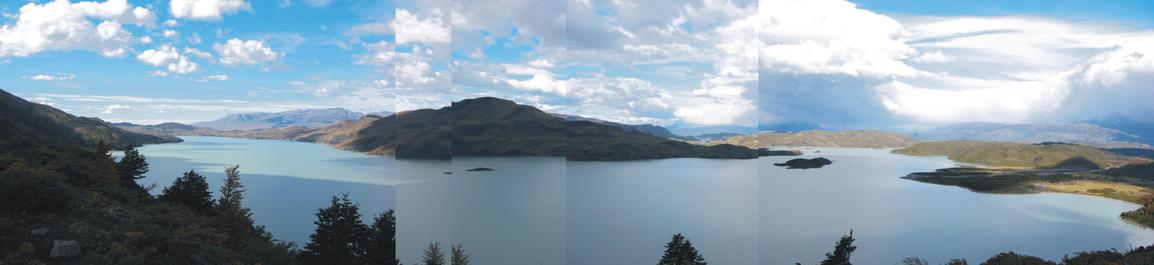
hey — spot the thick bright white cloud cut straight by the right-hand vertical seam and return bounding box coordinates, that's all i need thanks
[759,0,917,77]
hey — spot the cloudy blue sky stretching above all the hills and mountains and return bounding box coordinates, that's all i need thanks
[0,0,1154,134]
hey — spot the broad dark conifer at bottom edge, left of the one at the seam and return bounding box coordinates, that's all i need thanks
[300,194,369,265]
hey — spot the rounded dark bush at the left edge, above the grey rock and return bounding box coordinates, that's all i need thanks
[0,165,75,212]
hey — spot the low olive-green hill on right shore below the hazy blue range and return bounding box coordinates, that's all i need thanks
[893,141,1148,168]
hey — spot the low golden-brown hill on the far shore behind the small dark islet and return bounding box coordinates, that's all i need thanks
[711,130,915,149]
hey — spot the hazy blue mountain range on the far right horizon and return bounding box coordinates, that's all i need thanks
[914,122,1151,149]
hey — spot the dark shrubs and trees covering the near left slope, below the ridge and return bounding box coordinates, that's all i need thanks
[0,144,294,264]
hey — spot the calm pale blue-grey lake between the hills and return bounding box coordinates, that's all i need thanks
[140,137,1154,265]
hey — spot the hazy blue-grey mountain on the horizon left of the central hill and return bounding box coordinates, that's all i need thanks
[190,108,365,130]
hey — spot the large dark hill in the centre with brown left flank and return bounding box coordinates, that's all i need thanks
[265,98,757,160]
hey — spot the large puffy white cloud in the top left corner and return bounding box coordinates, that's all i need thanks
[0,0,156,58]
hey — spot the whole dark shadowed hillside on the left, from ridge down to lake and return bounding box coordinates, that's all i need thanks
[0,93,294,264]
